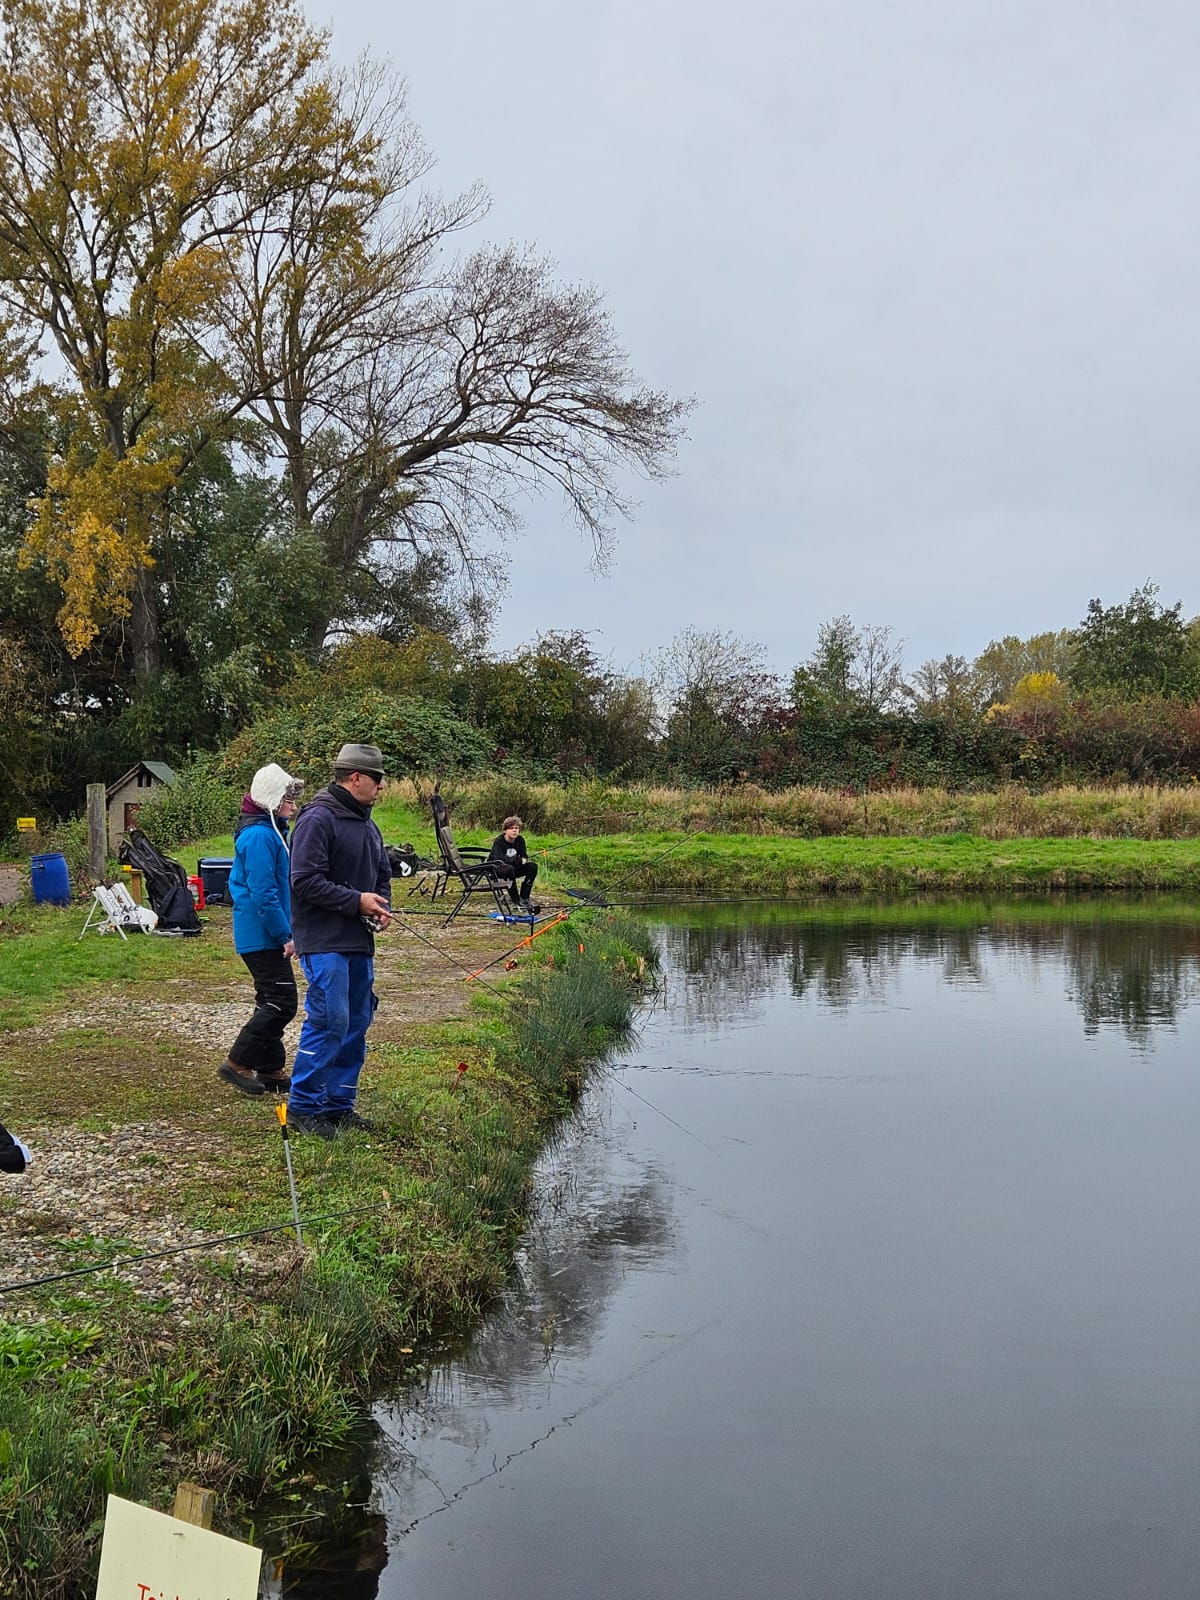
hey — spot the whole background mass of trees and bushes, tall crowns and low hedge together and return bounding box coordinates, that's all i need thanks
[0,0,1200,832]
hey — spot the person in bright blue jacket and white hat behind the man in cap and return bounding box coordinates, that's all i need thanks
[216,762,304,1094]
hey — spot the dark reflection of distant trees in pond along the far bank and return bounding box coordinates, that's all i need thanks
[659,917,1200,1046]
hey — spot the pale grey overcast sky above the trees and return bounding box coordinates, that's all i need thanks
[326,0,1200,672]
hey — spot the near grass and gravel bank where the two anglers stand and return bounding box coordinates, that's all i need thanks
[0,909,651,1600]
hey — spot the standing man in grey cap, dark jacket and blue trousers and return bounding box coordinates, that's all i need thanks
[288,744,392,1139]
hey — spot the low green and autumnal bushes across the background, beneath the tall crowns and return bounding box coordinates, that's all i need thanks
[0,518,1200,826]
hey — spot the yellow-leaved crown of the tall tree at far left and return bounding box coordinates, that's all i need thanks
[0,0,344,654]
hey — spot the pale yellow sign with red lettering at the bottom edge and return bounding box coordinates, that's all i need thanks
[96,1494,262,1600]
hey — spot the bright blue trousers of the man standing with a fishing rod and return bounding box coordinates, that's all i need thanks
[288,954,378,1117]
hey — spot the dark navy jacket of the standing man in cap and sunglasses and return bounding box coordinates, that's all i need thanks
[291,784,392,955]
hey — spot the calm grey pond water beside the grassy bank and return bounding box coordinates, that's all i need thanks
[284,906,1200,1600]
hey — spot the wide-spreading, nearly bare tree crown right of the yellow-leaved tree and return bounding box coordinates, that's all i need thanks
[219,66,688,649]
